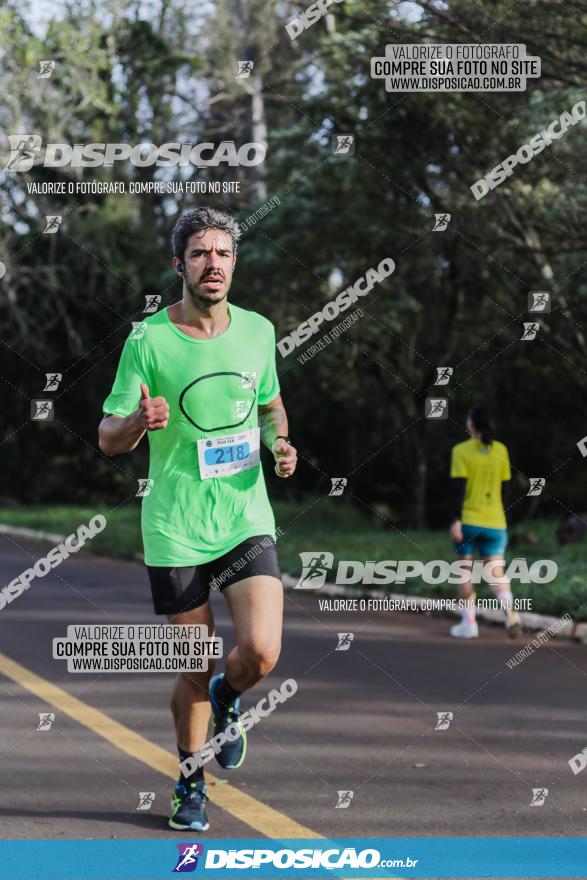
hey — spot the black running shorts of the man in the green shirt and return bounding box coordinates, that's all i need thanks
[147,535,281,614]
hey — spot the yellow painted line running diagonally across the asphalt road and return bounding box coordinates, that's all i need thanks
[0,654,322,839]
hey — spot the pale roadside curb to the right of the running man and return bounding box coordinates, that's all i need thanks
[283,574,587,642]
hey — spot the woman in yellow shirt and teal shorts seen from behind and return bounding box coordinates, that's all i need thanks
[450,406,522,639]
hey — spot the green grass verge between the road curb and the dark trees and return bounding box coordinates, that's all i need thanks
[0,497,587,620]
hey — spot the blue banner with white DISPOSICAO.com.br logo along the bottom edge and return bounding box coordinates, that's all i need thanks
[0,835,587,880]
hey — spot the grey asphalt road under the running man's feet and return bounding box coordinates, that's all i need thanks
[0,536,587,839]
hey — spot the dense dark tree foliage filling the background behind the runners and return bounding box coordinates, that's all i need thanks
[0,0,587,525]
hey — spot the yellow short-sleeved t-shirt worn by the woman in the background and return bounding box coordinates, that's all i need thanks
[450,438,512,529]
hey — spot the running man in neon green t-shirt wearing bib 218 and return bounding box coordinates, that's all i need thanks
[99,208,297,831]
